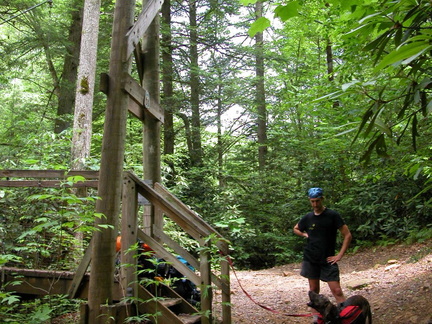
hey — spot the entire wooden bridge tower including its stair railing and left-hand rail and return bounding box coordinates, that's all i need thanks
[0,0,231,324]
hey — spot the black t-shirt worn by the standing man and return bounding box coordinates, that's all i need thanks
[298,208,345,263]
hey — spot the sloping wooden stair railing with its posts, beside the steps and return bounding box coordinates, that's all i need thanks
[122,172,231,324]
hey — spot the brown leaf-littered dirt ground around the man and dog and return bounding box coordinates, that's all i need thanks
[226,240,432,324]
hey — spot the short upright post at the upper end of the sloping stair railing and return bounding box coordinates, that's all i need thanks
[120,174,138,297]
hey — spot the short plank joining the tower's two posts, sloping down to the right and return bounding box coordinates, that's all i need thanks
[122,73,164,123]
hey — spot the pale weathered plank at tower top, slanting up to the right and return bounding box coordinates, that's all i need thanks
[124,0,163,61]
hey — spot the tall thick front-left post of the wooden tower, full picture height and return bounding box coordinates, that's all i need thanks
[88,0,135,324]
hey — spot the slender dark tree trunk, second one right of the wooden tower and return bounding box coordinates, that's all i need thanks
[189,0,203,166]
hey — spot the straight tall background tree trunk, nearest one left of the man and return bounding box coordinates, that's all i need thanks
[255,1,267,170]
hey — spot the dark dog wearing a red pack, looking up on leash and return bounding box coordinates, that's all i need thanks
[307,291,372,324]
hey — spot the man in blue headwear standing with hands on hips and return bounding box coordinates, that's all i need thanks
[294,188,352,303]
